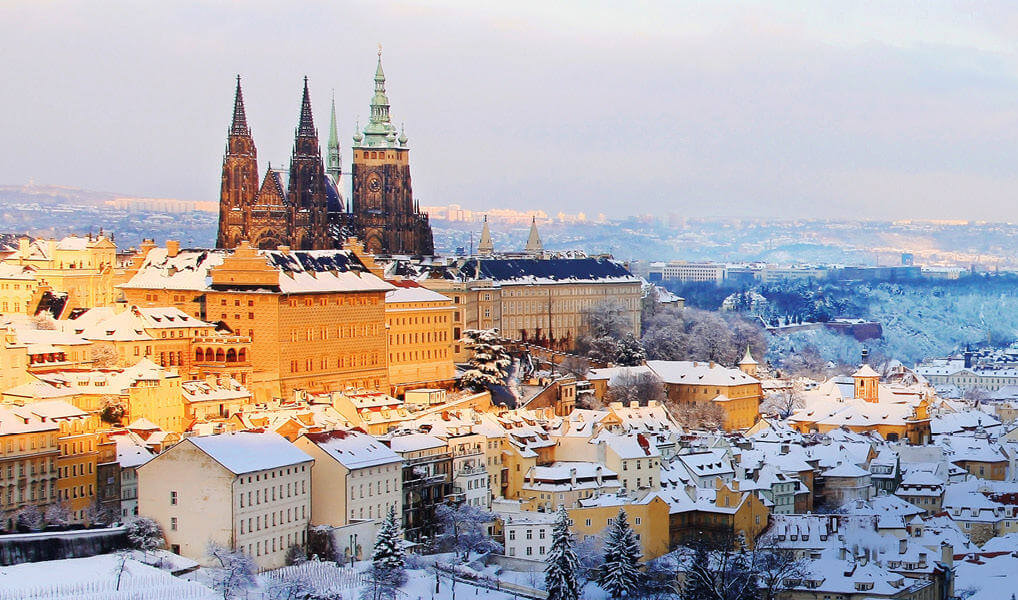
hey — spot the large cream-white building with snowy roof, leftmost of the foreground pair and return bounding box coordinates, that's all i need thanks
[137,432,314,568]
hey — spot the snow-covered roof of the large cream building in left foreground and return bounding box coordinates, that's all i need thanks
[187,431,313,475]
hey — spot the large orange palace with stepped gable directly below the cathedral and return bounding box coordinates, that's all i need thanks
[120,238,395,401]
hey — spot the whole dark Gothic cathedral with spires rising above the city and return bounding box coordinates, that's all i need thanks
[216,52,435,255]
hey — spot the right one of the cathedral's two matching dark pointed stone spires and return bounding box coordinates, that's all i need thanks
[287,77,333,250]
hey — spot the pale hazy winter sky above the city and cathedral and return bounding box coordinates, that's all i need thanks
[0,0,1018,220]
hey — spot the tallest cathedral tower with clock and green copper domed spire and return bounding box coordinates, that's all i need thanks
[350,48,435,255]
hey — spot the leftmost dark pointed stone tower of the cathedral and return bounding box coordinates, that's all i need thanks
[216,75,259,248]
